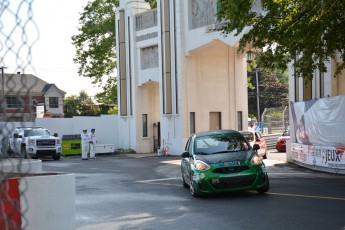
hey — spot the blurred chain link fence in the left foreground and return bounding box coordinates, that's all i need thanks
[0,0,39,230]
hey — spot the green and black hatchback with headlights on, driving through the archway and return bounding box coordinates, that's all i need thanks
[181,130,269,197]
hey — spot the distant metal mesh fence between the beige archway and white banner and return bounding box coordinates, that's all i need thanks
[262,106,289,134]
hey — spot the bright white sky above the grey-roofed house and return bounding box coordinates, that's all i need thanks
[0,0,105,97]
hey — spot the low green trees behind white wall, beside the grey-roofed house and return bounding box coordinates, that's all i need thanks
[64,91,101,117]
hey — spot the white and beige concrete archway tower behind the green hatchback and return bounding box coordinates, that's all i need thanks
[115,0,248,155]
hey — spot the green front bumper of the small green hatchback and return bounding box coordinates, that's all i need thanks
[192,165,268,194]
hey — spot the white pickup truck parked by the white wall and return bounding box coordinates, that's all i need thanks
[8,127,62,160]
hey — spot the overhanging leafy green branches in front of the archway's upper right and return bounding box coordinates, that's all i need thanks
[218,0,345,80]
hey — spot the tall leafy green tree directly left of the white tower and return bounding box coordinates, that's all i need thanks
[72,0,156,104]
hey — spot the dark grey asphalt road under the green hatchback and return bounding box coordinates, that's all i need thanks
[43,151,345,230]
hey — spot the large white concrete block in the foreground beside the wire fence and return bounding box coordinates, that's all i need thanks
[19,174,75,230]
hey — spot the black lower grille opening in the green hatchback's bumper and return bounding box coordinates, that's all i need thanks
[210,175,256,189]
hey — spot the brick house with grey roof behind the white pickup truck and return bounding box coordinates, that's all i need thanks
[0,72,66,122]
